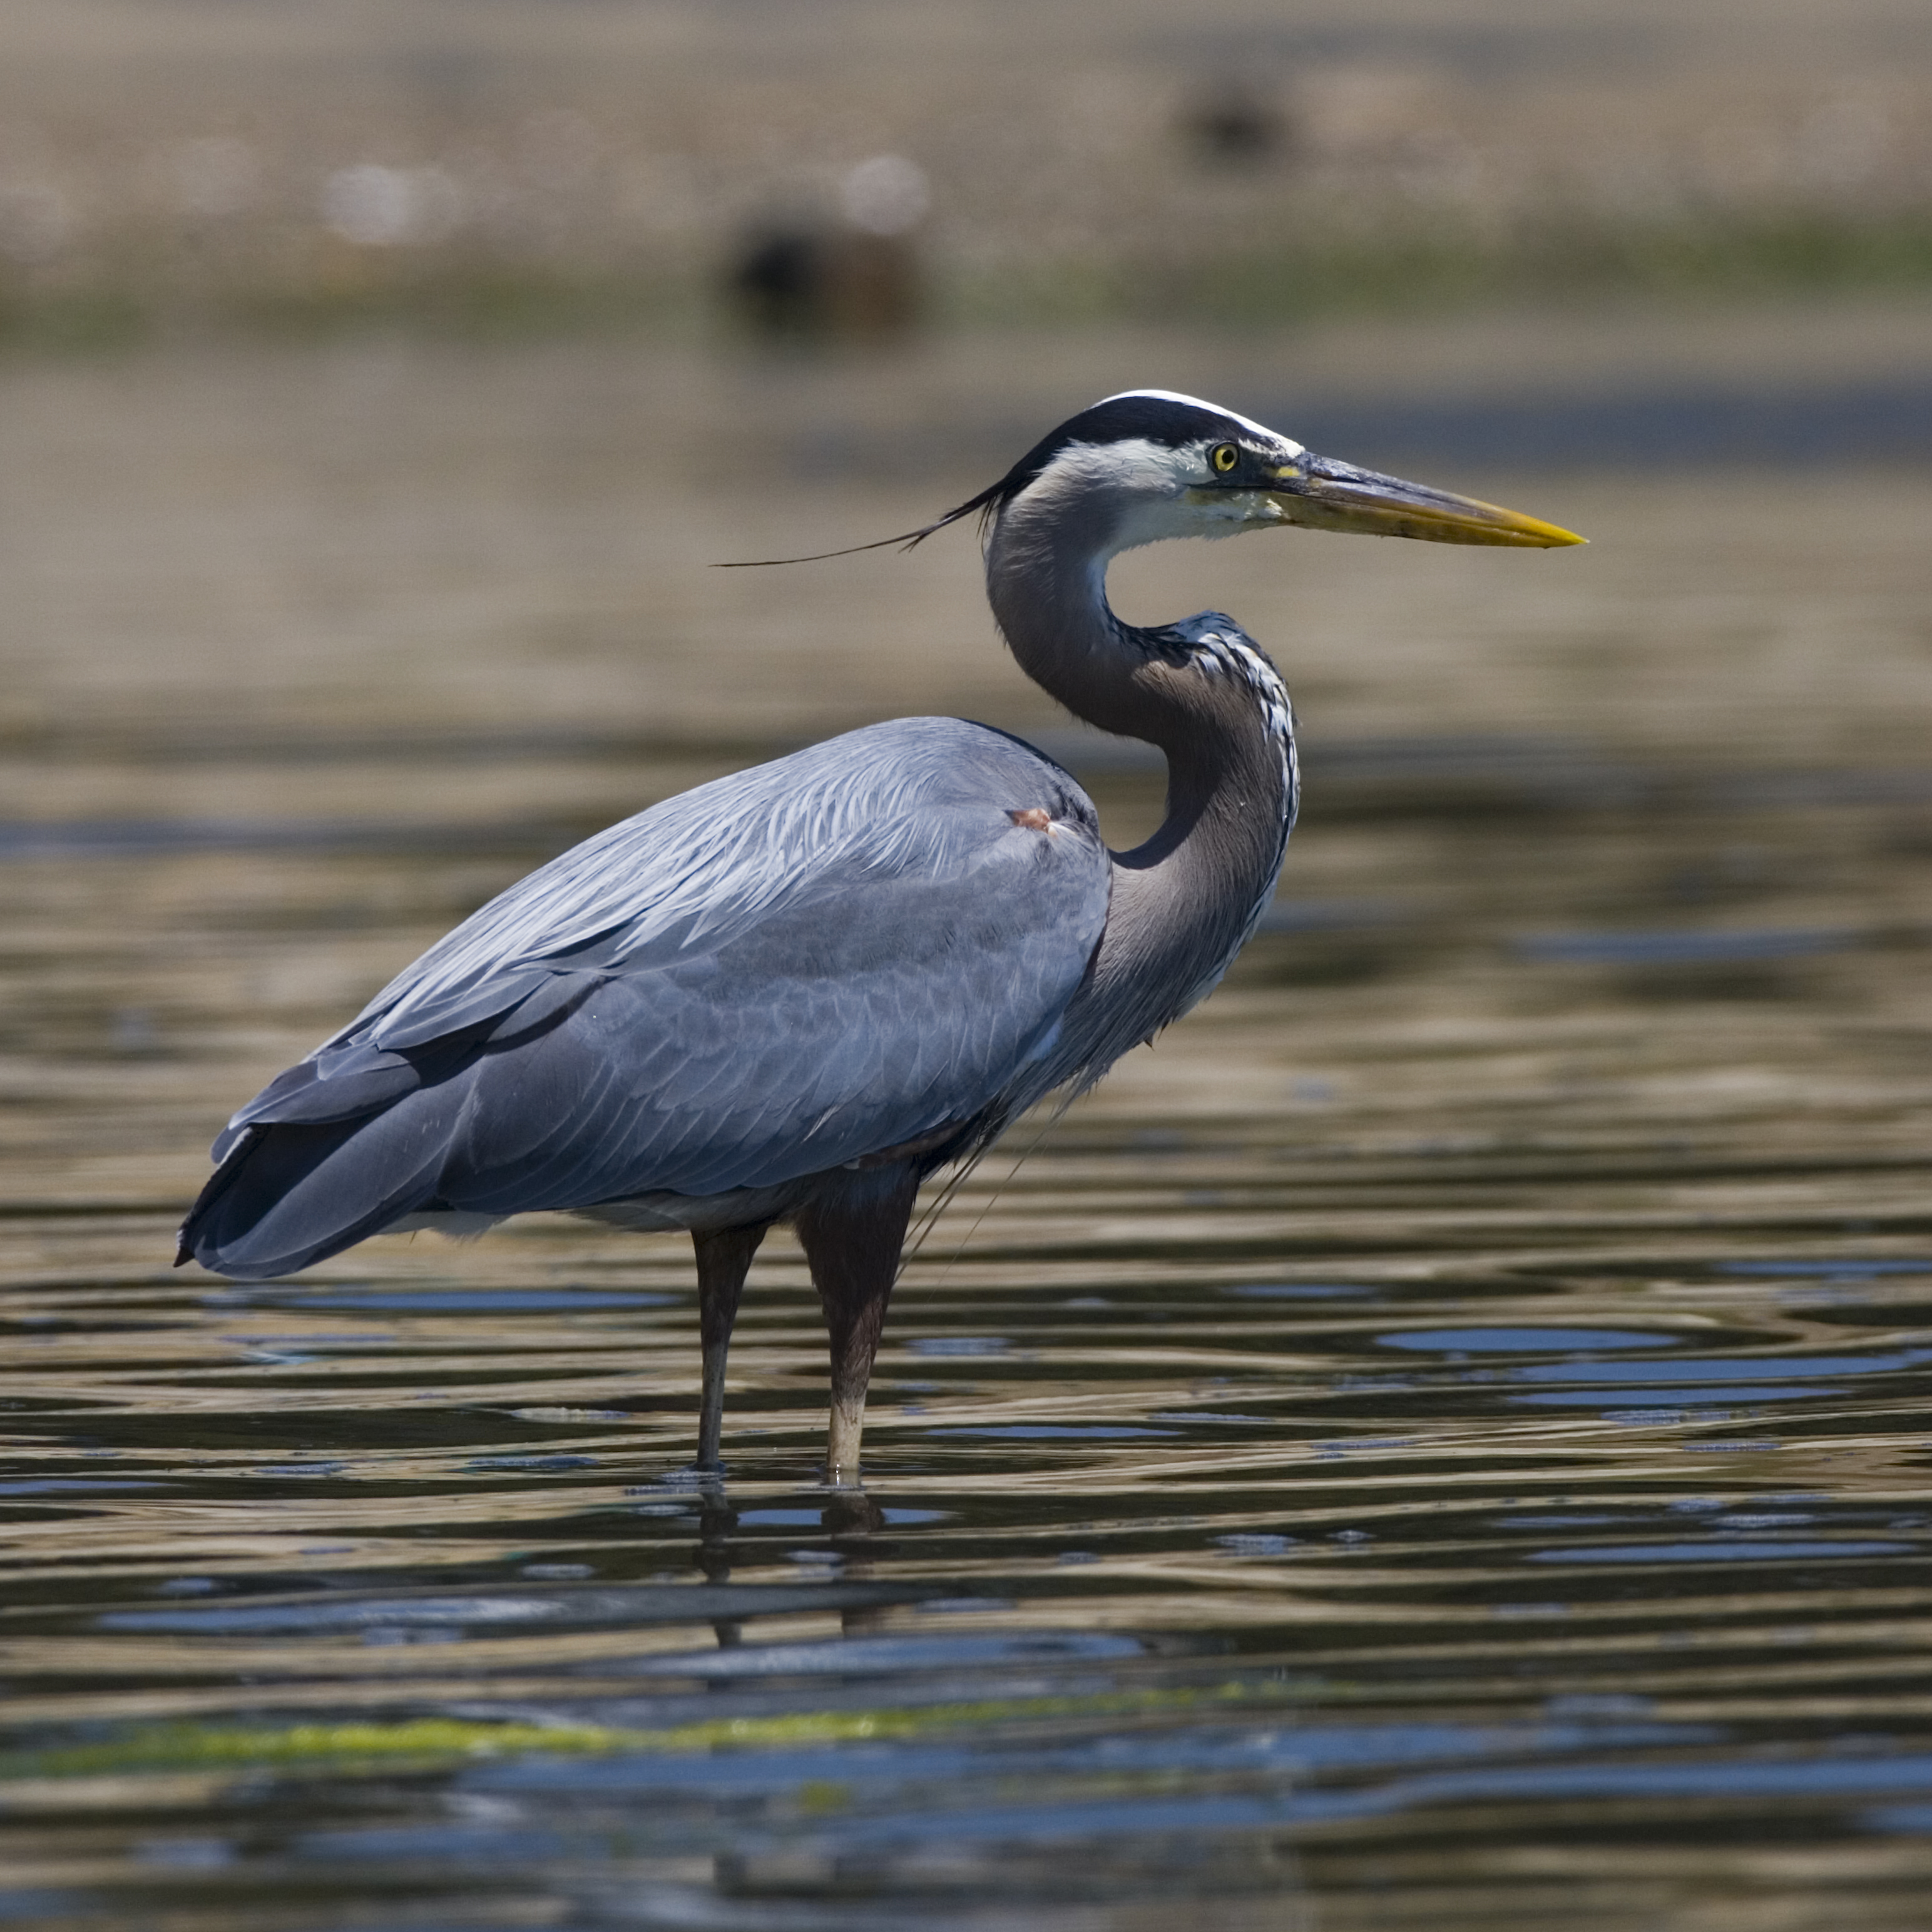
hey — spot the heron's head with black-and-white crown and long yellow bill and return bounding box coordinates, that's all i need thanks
[966,388,1584,555]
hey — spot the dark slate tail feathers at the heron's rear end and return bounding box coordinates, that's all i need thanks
[174,1115,435,1281]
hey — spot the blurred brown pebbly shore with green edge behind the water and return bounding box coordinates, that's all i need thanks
[0,0,1932,352]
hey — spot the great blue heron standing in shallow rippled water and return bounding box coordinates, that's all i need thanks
[180,391,1582,1482]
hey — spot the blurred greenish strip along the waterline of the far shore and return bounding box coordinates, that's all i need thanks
[0,207,1932,355]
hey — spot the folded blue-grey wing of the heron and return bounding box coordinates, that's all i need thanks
[197,718,1111,1265]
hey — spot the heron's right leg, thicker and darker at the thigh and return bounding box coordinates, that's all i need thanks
[796,1161,919,1488]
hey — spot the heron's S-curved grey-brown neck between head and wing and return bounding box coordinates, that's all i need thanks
[987,481,1296,1082]
